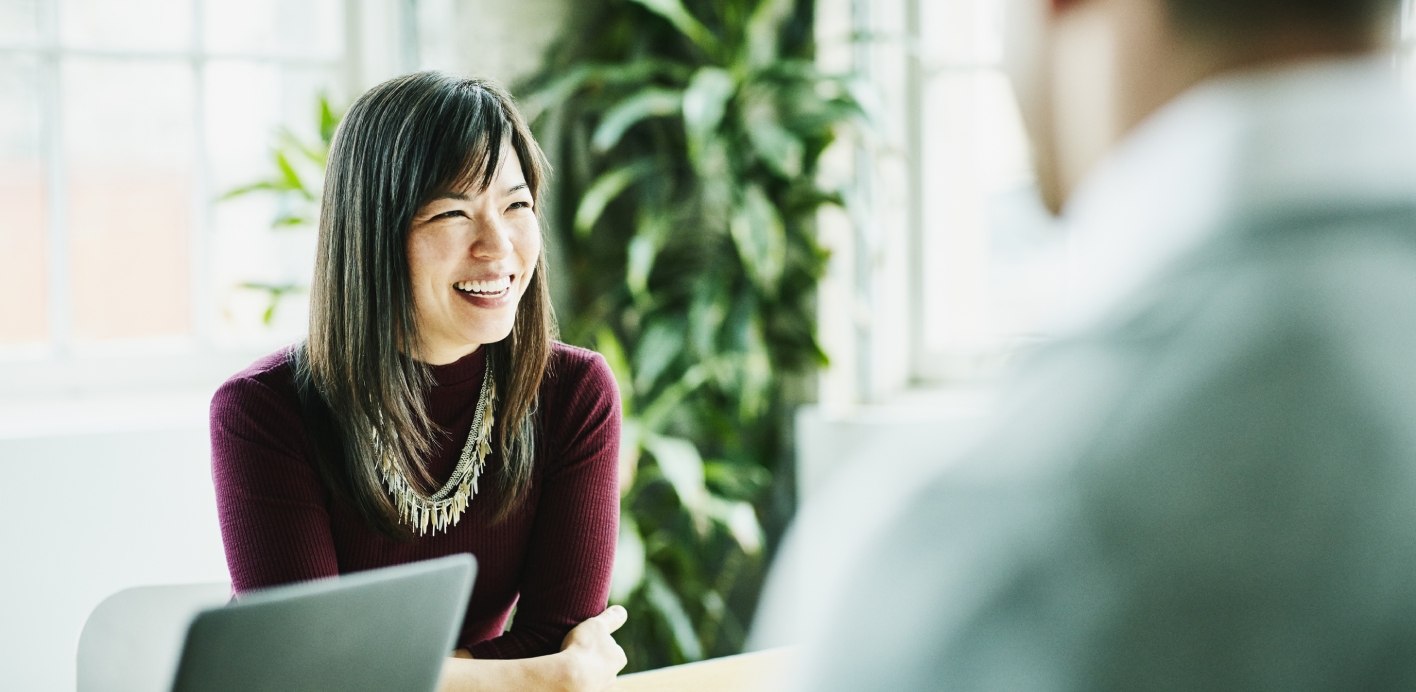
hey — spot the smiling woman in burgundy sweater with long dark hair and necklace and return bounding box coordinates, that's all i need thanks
[211,72,624,689]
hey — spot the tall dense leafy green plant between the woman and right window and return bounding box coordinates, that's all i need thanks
[518,0,865,671]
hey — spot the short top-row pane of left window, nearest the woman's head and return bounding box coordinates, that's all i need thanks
[202,0,344,59]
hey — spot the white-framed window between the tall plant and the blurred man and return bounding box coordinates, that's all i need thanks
[817,0,1063,406]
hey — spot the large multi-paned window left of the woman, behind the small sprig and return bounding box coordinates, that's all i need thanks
[0,0,348,361]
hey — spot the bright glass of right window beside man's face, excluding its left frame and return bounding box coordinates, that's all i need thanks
[908,0,1065,382]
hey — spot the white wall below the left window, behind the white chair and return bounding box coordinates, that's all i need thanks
[0,413,228,692]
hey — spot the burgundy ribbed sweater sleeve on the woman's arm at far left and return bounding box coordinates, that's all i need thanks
[211,376,338,593]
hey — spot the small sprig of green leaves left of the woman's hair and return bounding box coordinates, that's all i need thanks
[218,95,341,324]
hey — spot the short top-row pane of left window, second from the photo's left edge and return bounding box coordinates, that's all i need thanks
[55,0,193,51]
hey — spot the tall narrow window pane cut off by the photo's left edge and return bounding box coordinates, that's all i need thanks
[0,59,47,344]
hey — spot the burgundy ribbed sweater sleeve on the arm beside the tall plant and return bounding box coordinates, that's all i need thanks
[470,354,620,658]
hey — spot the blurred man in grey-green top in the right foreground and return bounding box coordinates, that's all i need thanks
[804,0,1416,691]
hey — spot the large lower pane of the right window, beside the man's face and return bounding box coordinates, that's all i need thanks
[923,69,1062,352]
